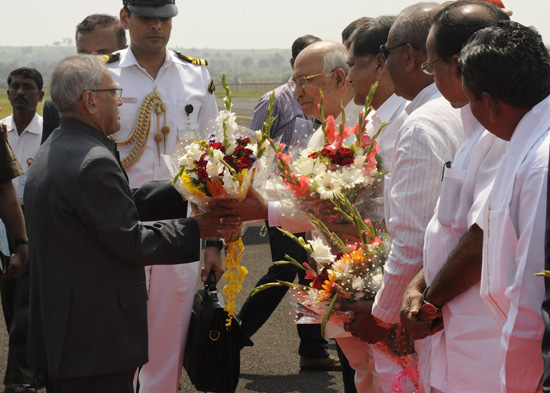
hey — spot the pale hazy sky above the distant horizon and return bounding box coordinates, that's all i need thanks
[0,0,550,49]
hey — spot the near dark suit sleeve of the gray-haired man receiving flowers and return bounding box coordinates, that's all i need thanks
[74,149,200,265]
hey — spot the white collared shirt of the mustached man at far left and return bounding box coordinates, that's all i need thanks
[0,113,42,205]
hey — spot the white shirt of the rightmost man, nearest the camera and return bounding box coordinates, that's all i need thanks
[479,93,550,393]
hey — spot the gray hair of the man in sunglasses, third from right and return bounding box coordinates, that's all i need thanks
[390,2,443,54]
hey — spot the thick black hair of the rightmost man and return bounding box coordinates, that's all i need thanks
[459,21,550,108]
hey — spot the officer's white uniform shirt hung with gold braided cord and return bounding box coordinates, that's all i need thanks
[106,48,218,187]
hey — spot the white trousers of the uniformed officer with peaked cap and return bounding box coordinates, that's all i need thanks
[139,262,200,393]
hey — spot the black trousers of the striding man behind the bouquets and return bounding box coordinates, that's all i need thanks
[239,222,329,357]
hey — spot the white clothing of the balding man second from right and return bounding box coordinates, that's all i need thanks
[423,105,508,393]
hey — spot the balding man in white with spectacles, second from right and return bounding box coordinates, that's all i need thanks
[396,2,509,393]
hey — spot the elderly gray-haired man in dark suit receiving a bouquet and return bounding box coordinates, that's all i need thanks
[25,55,234,393]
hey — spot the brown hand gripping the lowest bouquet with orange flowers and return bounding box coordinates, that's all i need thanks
[335,301,390,344]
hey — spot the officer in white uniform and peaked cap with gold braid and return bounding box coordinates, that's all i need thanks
[107,0,219,393]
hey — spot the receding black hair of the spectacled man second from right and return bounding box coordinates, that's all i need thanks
[432,1,510,63]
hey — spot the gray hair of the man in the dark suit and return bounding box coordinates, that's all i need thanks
[50,55,104,115]
